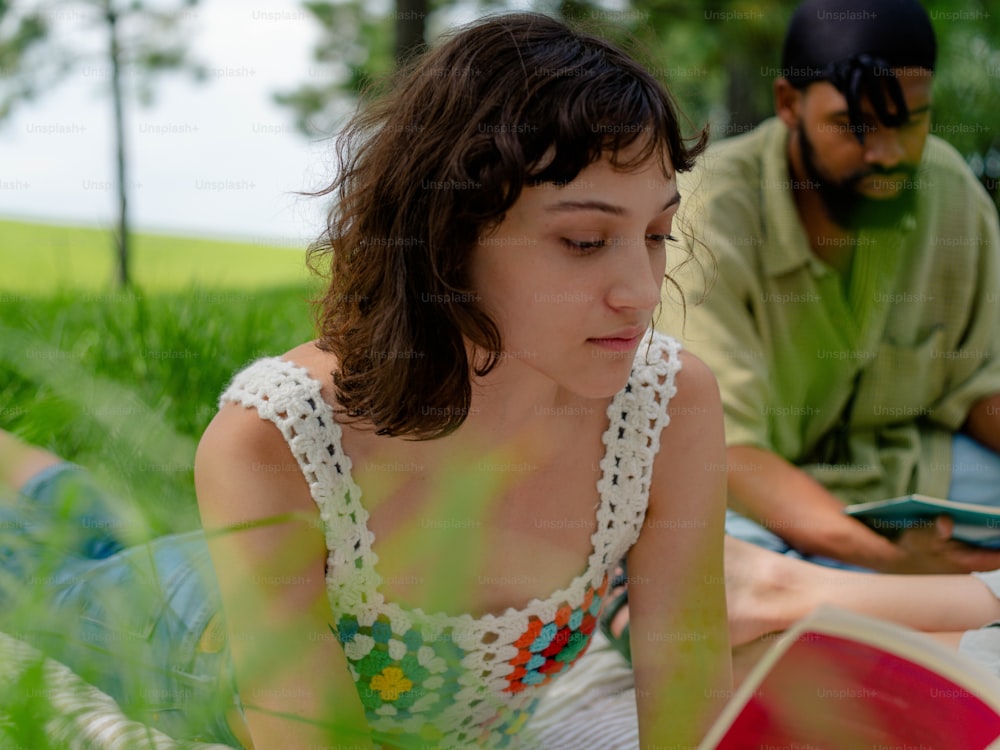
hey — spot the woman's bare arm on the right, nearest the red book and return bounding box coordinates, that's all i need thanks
[628,353,732,748]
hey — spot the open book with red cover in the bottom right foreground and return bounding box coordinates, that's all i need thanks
[699,607,1000,750]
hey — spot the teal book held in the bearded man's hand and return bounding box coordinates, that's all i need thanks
[845,495,1000,549]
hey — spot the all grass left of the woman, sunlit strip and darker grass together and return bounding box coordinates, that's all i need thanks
[0,221,318,750]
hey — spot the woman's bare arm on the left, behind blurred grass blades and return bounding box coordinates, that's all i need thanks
[195,405,371,750]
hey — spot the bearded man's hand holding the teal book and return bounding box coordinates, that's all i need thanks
[882,516,1000,573]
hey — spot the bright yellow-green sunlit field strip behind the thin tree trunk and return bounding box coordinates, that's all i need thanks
[0,220,309,295]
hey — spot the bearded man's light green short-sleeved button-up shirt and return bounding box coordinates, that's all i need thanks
[659,119,1000,502]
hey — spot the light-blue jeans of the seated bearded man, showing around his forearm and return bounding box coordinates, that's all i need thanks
[726,433,1000,570]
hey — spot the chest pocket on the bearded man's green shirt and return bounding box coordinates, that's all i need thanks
[851,328,946,428]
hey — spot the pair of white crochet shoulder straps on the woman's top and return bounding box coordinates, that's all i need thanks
[220,331,681,628]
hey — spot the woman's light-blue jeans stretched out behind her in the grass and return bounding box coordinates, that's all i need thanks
[0,464,242,748]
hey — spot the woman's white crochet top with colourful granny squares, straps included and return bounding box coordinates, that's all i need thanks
[220,331,680,749]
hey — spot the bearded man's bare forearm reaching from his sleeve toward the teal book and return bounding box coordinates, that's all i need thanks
[727,446,900,570]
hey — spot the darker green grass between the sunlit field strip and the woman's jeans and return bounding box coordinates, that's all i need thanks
[0,287,312,531]
